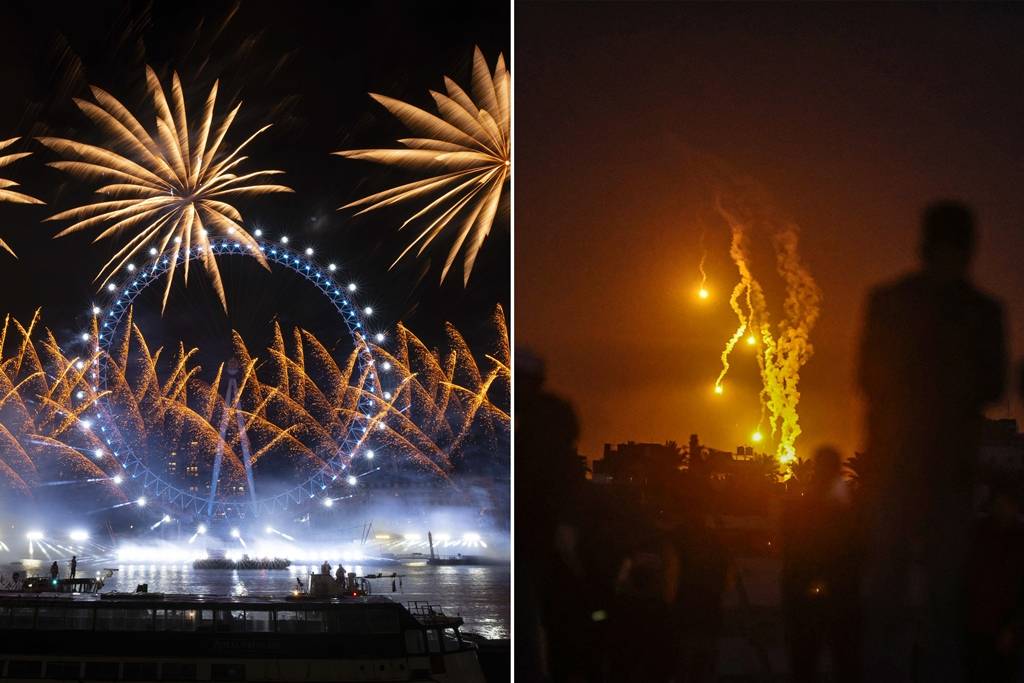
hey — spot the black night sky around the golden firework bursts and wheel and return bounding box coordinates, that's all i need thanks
[0,2,511,362]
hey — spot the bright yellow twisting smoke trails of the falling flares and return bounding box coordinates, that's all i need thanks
[715,194,821,464]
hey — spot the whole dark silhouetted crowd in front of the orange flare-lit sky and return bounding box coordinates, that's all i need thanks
[515,202,1024,683]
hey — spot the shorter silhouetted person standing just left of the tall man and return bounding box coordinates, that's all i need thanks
[781,447,862,683]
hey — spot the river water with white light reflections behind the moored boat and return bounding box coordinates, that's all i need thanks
[94,563,511,638]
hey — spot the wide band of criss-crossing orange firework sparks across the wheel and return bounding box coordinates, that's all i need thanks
[0,308,510,501]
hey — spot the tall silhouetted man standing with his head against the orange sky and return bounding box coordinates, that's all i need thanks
[859,202,1006,682]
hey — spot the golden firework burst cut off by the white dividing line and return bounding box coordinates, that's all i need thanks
[335,48,512,284]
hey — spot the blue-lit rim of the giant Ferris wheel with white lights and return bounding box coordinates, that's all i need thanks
[80,239,383,517]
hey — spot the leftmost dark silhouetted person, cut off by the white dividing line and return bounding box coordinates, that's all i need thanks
[515,350,610,682]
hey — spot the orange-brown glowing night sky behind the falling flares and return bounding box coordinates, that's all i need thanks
[515,2,1024,458]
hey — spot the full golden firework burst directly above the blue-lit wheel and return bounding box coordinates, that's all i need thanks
[39,67,292,309]
